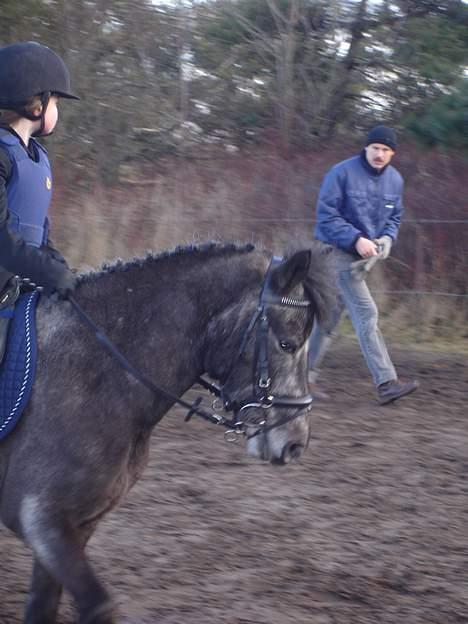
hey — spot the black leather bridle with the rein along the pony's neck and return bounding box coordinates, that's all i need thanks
[68,256,313,442]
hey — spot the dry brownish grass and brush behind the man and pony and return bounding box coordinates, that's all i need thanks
[48,147,468,348]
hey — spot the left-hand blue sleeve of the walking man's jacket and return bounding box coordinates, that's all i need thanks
[317,168,362,251]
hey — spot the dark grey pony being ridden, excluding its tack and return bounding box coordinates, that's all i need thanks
[0,243,333,624]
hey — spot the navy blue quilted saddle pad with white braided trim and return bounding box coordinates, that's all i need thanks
[0,291,39,440]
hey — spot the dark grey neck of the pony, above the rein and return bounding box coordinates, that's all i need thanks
[77,250,267,404]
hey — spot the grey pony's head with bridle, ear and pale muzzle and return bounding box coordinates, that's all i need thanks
[205,246,334,464]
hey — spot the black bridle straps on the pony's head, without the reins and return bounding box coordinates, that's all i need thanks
[199,256,313,439]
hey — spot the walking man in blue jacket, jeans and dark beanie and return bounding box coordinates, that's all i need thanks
[309,126,418,405]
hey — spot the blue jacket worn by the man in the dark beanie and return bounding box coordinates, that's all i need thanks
[314,152,403,252]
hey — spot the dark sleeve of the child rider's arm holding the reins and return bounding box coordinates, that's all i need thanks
[0,149,69,293]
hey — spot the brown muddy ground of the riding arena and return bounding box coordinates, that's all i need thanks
[0,339,468,624]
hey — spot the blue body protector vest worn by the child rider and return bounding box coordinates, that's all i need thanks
[0,129,52,247]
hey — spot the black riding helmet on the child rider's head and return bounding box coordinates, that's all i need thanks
[0,41,80,135]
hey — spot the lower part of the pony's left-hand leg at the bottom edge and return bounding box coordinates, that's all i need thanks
[24,558,62,624]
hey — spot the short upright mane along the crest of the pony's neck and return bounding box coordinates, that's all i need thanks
[78,241,256,284]
